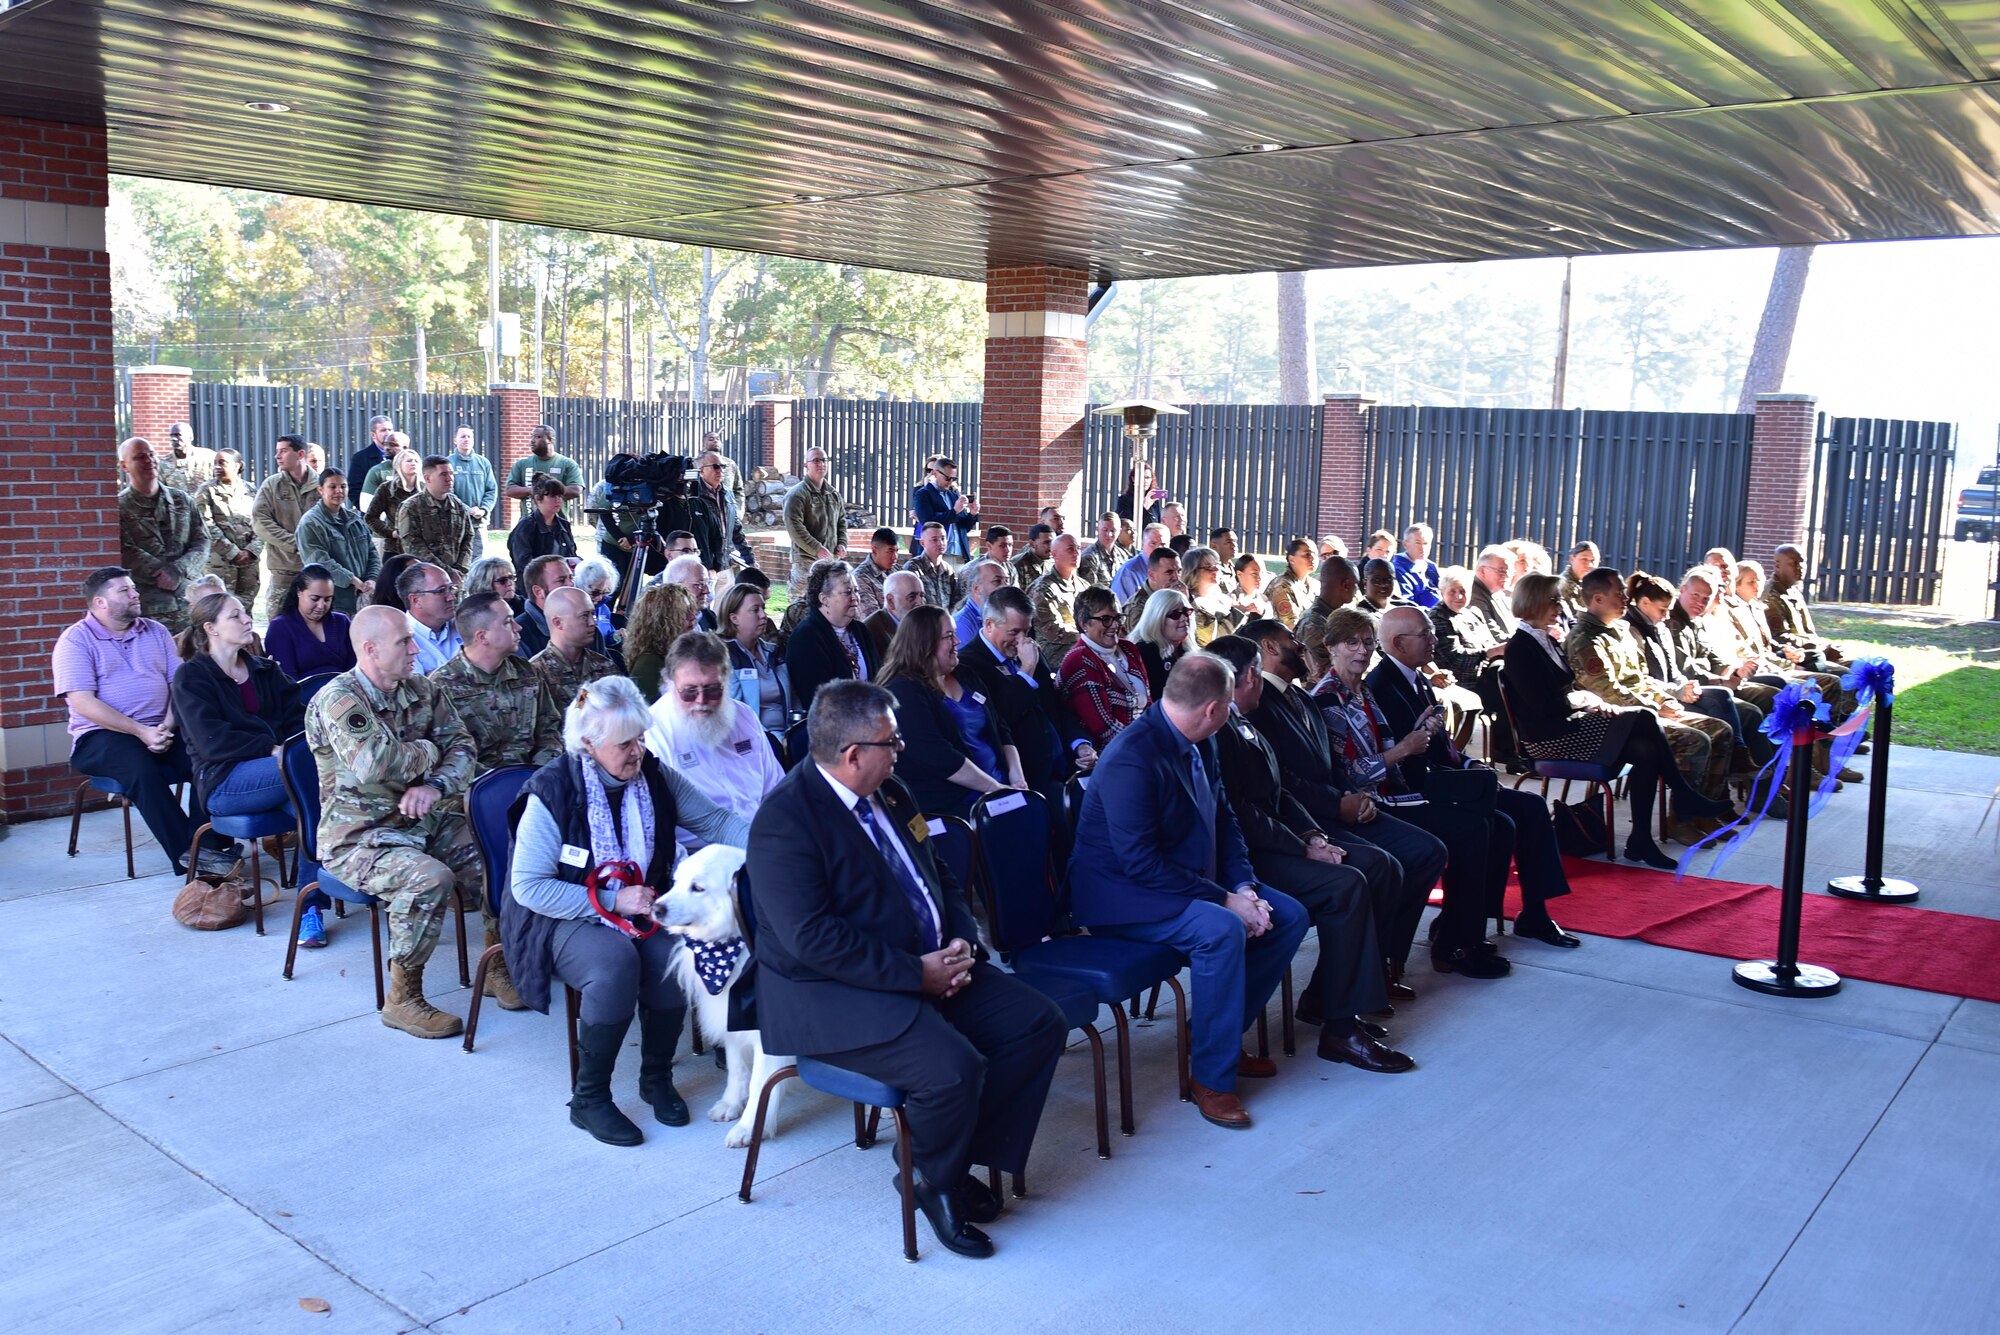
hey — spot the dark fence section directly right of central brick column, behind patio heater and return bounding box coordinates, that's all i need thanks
[1068,404,1320,552]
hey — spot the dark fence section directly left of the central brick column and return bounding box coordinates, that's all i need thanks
[792,398,980,532]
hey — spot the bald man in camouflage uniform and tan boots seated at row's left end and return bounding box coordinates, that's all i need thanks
[306,607,484,1039]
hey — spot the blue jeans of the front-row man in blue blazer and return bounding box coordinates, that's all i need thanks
[1090,885,1312,1093]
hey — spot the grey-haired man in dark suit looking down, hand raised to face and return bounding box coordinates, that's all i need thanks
[958,584,1098,811]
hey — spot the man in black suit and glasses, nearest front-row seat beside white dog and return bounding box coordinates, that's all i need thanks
[746,681,1068,1257]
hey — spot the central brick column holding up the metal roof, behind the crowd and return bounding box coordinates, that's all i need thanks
[976,264,1090,534]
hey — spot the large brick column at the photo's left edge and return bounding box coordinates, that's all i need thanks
[0,116,114,817]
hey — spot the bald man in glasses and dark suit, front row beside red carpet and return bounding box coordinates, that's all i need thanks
[1368,608,1580,949]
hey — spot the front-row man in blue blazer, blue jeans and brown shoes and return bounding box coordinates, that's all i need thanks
[1070,652,1308,1131]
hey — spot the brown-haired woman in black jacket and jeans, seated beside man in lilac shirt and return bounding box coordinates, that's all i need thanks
[172,594,306,815]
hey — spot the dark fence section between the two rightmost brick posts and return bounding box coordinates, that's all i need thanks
[1354,408,1754,578]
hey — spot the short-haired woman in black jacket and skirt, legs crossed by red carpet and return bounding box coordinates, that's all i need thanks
[1500,574,1732,871]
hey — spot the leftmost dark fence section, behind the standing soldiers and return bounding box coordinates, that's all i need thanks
[188,382,500,482]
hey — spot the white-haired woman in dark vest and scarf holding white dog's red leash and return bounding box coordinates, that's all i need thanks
[500,677,750,1145]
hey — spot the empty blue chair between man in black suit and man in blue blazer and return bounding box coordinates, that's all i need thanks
[972,791,1192,1157]
